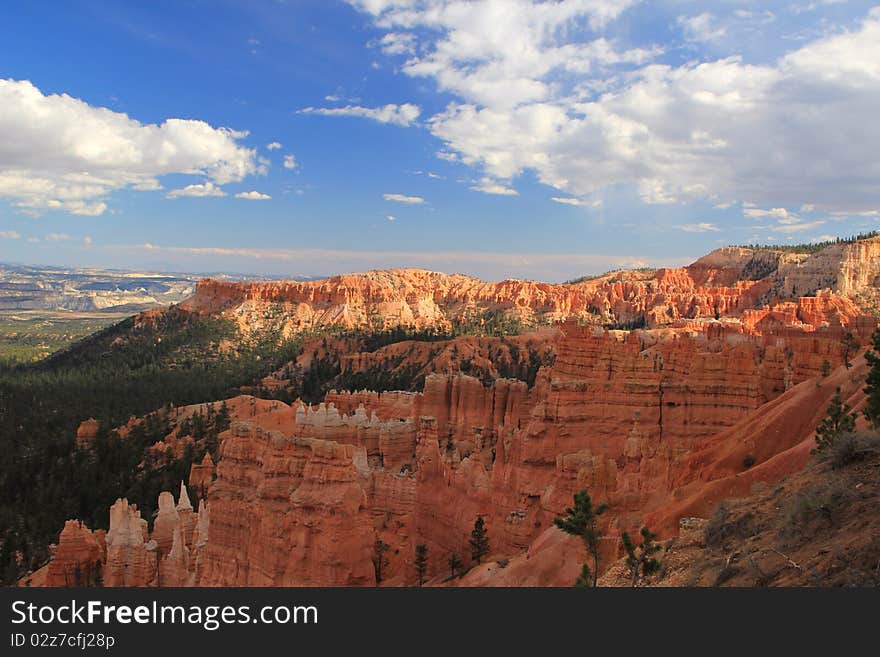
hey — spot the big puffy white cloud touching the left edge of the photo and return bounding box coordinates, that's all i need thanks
[0,79,266,215]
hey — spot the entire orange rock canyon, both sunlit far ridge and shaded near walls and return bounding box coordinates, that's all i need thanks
[30,238,880,586]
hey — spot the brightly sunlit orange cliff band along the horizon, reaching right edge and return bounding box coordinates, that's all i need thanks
[180,238,880,335]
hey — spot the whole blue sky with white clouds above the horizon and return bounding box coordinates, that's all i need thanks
[0,0,880,281]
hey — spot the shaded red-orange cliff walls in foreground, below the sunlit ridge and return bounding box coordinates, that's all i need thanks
[44,304,870,586]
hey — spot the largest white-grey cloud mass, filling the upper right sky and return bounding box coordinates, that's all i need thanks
[350,0,880,212]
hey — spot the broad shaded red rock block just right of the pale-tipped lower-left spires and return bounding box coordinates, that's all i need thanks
[199,423,374,586]
